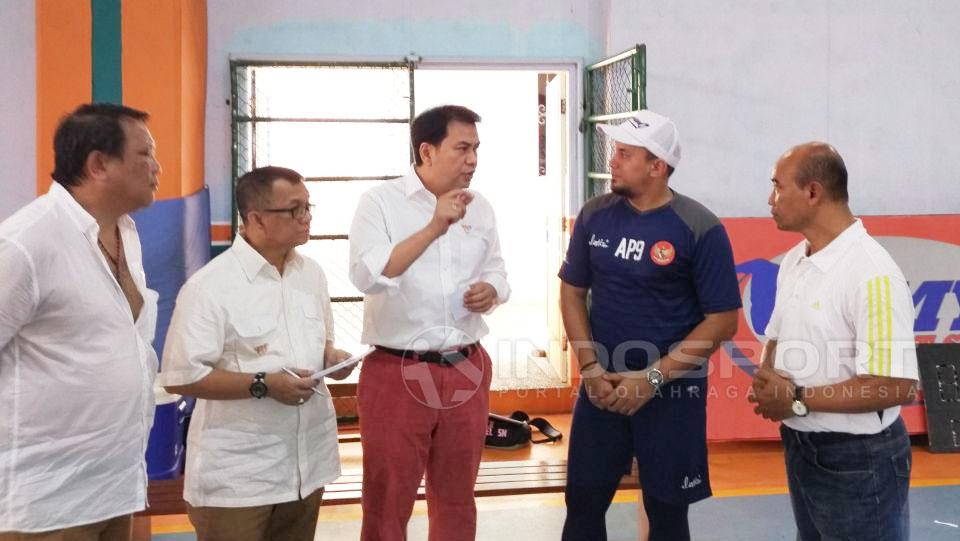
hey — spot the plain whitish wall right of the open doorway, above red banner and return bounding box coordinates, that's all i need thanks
[607,0,960,216]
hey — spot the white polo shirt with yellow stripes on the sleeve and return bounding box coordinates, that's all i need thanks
[765,220,917,434]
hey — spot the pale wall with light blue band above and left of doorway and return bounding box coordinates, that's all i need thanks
[206,0,609,222]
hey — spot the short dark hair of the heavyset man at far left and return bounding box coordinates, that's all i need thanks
[51,103,150,186]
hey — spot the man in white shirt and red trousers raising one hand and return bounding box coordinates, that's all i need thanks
[350,105,510,541]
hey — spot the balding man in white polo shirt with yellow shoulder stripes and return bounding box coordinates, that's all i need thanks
[750,143,917,541]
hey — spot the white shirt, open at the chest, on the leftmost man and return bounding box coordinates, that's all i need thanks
[0,182,157,532]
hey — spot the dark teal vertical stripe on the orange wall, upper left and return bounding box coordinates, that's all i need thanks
[90,0,123,104]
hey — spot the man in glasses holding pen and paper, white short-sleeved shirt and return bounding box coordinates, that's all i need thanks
[160,167,351,541]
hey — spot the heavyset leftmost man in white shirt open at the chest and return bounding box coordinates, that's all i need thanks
[0,104,160,541]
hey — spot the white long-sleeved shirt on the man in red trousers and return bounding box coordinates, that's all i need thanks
[350,168,510,350]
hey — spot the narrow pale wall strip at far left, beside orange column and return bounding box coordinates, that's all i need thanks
[0,0,36,221]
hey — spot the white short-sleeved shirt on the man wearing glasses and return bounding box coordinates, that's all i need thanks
[160,235,340,507]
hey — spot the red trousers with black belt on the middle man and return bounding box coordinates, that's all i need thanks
[357,346,492,541]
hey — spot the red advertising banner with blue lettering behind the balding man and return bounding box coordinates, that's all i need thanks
[707,215,960,440]
